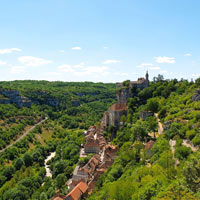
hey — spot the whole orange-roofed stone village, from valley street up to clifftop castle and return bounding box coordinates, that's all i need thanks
[52,72,150,200]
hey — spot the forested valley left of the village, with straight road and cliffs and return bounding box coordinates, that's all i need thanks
[0,81,116,200]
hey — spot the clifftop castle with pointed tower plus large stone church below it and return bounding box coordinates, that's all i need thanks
[101,71,149,130]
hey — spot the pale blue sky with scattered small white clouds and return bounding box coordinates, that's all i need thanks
[0,0,200,82]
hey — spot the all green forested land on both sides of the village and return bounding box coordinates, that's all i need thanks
[0,76,200,200]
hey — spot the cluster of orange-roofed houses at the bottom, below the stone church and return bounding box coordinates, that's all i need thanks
[53,126,118,200]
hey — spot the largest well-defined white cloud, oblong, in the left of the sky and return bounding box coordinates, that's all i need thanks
[18,56,53,67]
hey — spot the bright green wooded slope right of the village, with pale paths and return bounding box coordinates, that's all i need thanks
[89,76,200,200]
